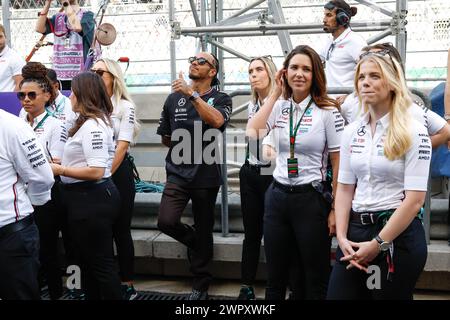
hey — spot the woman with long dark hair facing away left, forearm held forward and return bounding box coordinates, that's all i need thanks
[52,72,122,300]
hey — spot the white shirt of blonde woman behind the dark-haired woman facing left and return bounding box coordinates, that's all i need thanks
[111,95,136,144]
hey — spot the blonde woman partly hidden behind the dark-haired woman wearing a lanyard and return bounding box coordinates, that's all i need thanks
[238,57,277,300]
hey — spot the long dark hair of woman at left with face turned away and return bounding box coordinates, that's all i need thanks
[69,72,113,137]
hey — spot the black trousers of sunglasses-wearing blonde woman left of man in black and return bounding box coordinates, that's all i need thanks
[112,156,136,282]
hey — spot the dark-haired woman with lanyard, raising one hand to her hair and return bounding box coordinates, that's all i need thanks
[247,45,344,300]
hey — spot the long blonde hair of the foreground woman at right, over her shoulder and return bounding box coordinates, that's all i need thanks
[354,52,412,161]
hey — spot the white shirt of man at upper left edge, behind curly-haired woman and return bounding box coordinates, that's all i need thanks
[0,46,25,92]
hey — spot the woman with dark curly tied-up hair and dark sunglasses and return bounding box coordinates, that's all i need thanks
[17,62,67,300]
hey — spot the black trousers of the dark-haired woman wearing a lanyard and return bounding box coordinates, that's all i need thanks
[264,184,331,300]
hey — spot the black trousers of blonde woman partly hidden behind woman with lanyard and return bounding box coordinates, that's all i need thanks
[239,164,273,285]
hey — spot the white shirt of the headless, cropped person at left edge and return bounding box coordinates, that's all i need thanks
[0,110,54,227]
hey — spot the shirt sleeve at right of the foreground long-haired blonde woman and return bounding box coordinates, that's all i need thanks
[405,121,432,191]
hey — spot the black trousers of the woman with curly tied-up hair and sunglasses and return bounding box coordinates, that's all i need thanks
[34,183,66,300]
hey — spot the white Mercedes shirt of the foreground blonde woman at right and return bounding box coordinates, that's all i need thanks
[338,113,432,212]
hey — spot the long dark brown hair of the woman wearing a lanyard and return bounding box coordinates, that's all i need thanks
[283,45,339,109]
